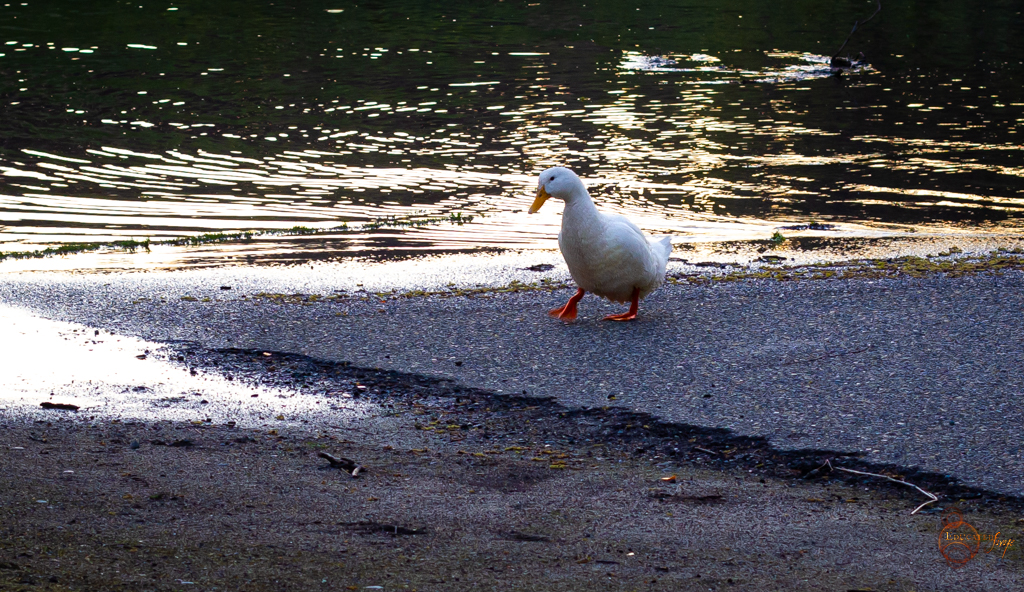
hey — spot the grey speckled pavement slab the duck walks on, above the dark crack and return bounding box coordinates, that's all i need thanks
[0,264,1024,496]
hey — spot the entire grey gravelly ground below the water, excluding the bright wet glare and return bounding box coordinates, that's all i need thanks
[0,264,1024,591]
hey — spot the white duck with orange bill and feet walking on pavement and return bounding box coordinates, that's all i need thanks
[529,167,672,321]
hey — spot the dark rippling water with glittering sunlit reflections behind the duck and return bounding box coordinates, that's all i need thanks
[0,0,1024,262]
